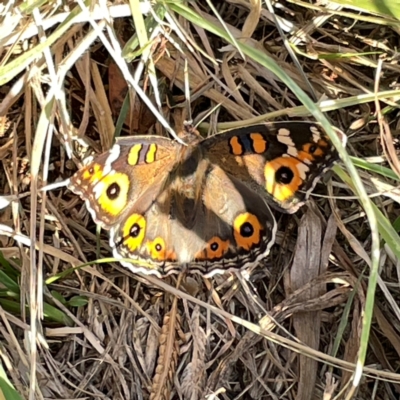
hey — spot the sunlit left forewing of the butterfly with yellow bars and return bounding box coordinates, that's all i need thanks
[68,136,180,229]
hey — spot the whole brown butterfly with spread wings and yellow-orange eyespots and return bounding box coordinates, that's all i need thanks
[69,123,346,276]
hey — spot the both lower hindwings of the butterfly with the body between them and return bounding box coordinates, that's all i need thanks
[110,150,276,276]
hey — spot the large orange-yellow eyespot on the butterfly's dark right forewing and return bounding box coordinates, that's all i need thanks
[264,157,309,201]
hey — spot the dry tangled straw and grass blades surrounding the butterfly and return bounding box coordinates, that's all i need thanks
[0,0,400,400]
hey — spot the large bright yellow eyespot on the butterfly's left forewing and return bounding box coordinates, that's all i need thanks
[93,171,129,216]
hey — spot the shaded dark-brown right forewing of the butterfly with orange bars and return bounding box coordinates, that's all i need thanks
[201,122,346,213]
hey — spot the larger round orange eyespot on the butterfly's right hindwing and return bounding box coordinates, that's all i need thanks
[233,213,262,250]
